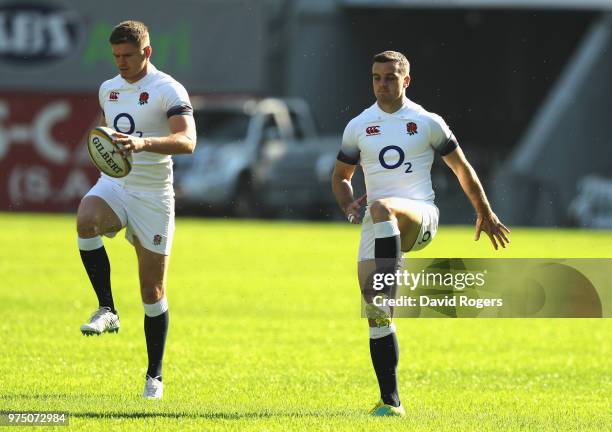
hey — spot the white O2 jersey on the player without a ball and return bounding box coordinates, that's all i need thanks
[338,99,457,204]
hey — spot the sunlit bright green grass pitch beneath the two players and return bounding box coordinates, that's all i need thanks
[0,213,612,431]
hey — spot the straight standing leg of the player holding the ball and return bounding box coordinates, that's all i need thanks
[134,237,169,399]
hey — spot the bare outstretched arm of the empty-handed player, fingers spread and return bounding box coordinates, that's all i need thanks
[442,147,510,249]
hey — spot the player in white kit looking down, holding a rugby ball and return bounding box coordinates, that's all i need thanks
[77,21,196,399]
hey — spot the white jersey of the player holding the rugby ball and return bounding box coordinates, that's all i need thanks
[98,63,193,191]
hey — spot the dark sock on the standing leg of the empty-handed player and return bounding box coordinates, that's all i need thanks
[370,333,400,407]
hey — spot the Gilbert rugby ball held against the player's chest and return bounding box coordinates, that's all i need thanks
[87,126,132,178]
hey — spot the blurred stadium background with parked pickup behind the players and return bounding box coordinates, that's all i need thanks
[0,0,612,227]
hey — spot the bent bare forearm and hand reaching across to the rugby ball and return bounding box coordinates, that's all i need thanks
[113,115,196,155]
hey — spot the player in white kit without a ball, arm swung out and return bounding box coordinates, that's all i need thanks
[332,51,509,416]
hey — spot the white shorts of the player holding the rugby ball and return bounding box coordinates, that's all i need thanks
[85,178,174,255]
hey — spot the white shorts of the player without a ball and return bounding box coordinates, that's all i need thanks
[358,198,440,261]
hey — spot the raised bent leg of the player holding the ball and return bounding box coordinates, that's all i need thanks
[77,195,121,335]
